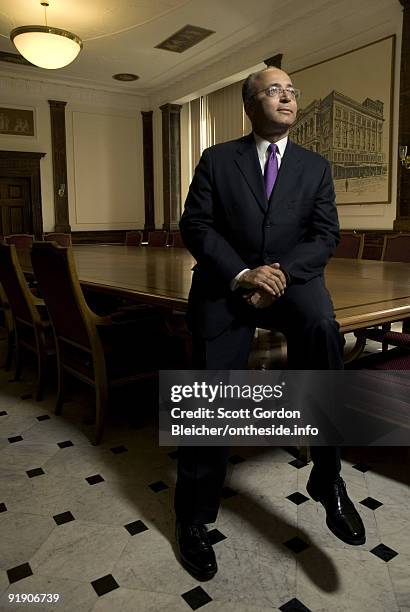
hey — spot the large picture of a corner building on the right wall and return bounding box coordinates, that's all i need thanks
[291,36,396,205]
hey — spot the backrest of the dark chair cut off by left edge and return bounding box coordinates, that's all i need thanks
[0,242,40,325]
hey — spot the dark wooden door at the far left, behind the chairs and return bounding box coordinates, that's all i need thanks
[0,177,33,236]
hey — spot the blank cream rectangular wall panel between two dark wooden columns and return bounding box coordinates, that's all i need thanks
[70,110,144,230]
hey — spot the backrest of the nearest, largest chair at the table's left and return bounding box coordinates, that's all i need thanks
[31,241,95,353]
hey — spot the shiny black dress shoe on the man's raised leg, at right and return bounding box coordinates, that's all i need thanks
[306,476,366,546]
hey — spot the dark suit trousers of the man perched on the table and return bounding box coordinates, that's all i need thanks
[175,277,343,523]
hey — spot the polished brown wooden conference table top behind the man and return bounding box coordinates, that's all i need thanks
[67,245,410,332]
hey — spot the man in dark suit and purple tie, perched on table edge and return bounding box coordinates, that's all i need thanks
[175,68,365,579]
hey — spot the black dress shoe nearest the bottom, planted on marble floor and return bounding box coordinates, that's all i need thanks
[176,521,218,580]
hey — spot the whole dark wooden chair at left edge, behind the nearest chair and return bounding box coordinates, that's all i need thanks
[0,243,55,401]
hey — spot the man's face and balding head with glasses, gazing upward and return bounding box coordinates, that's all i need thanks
[245,68,297,136]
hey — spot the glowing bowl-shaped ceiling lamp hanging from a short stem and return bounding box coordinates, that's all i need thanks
[10,0,83,70]
